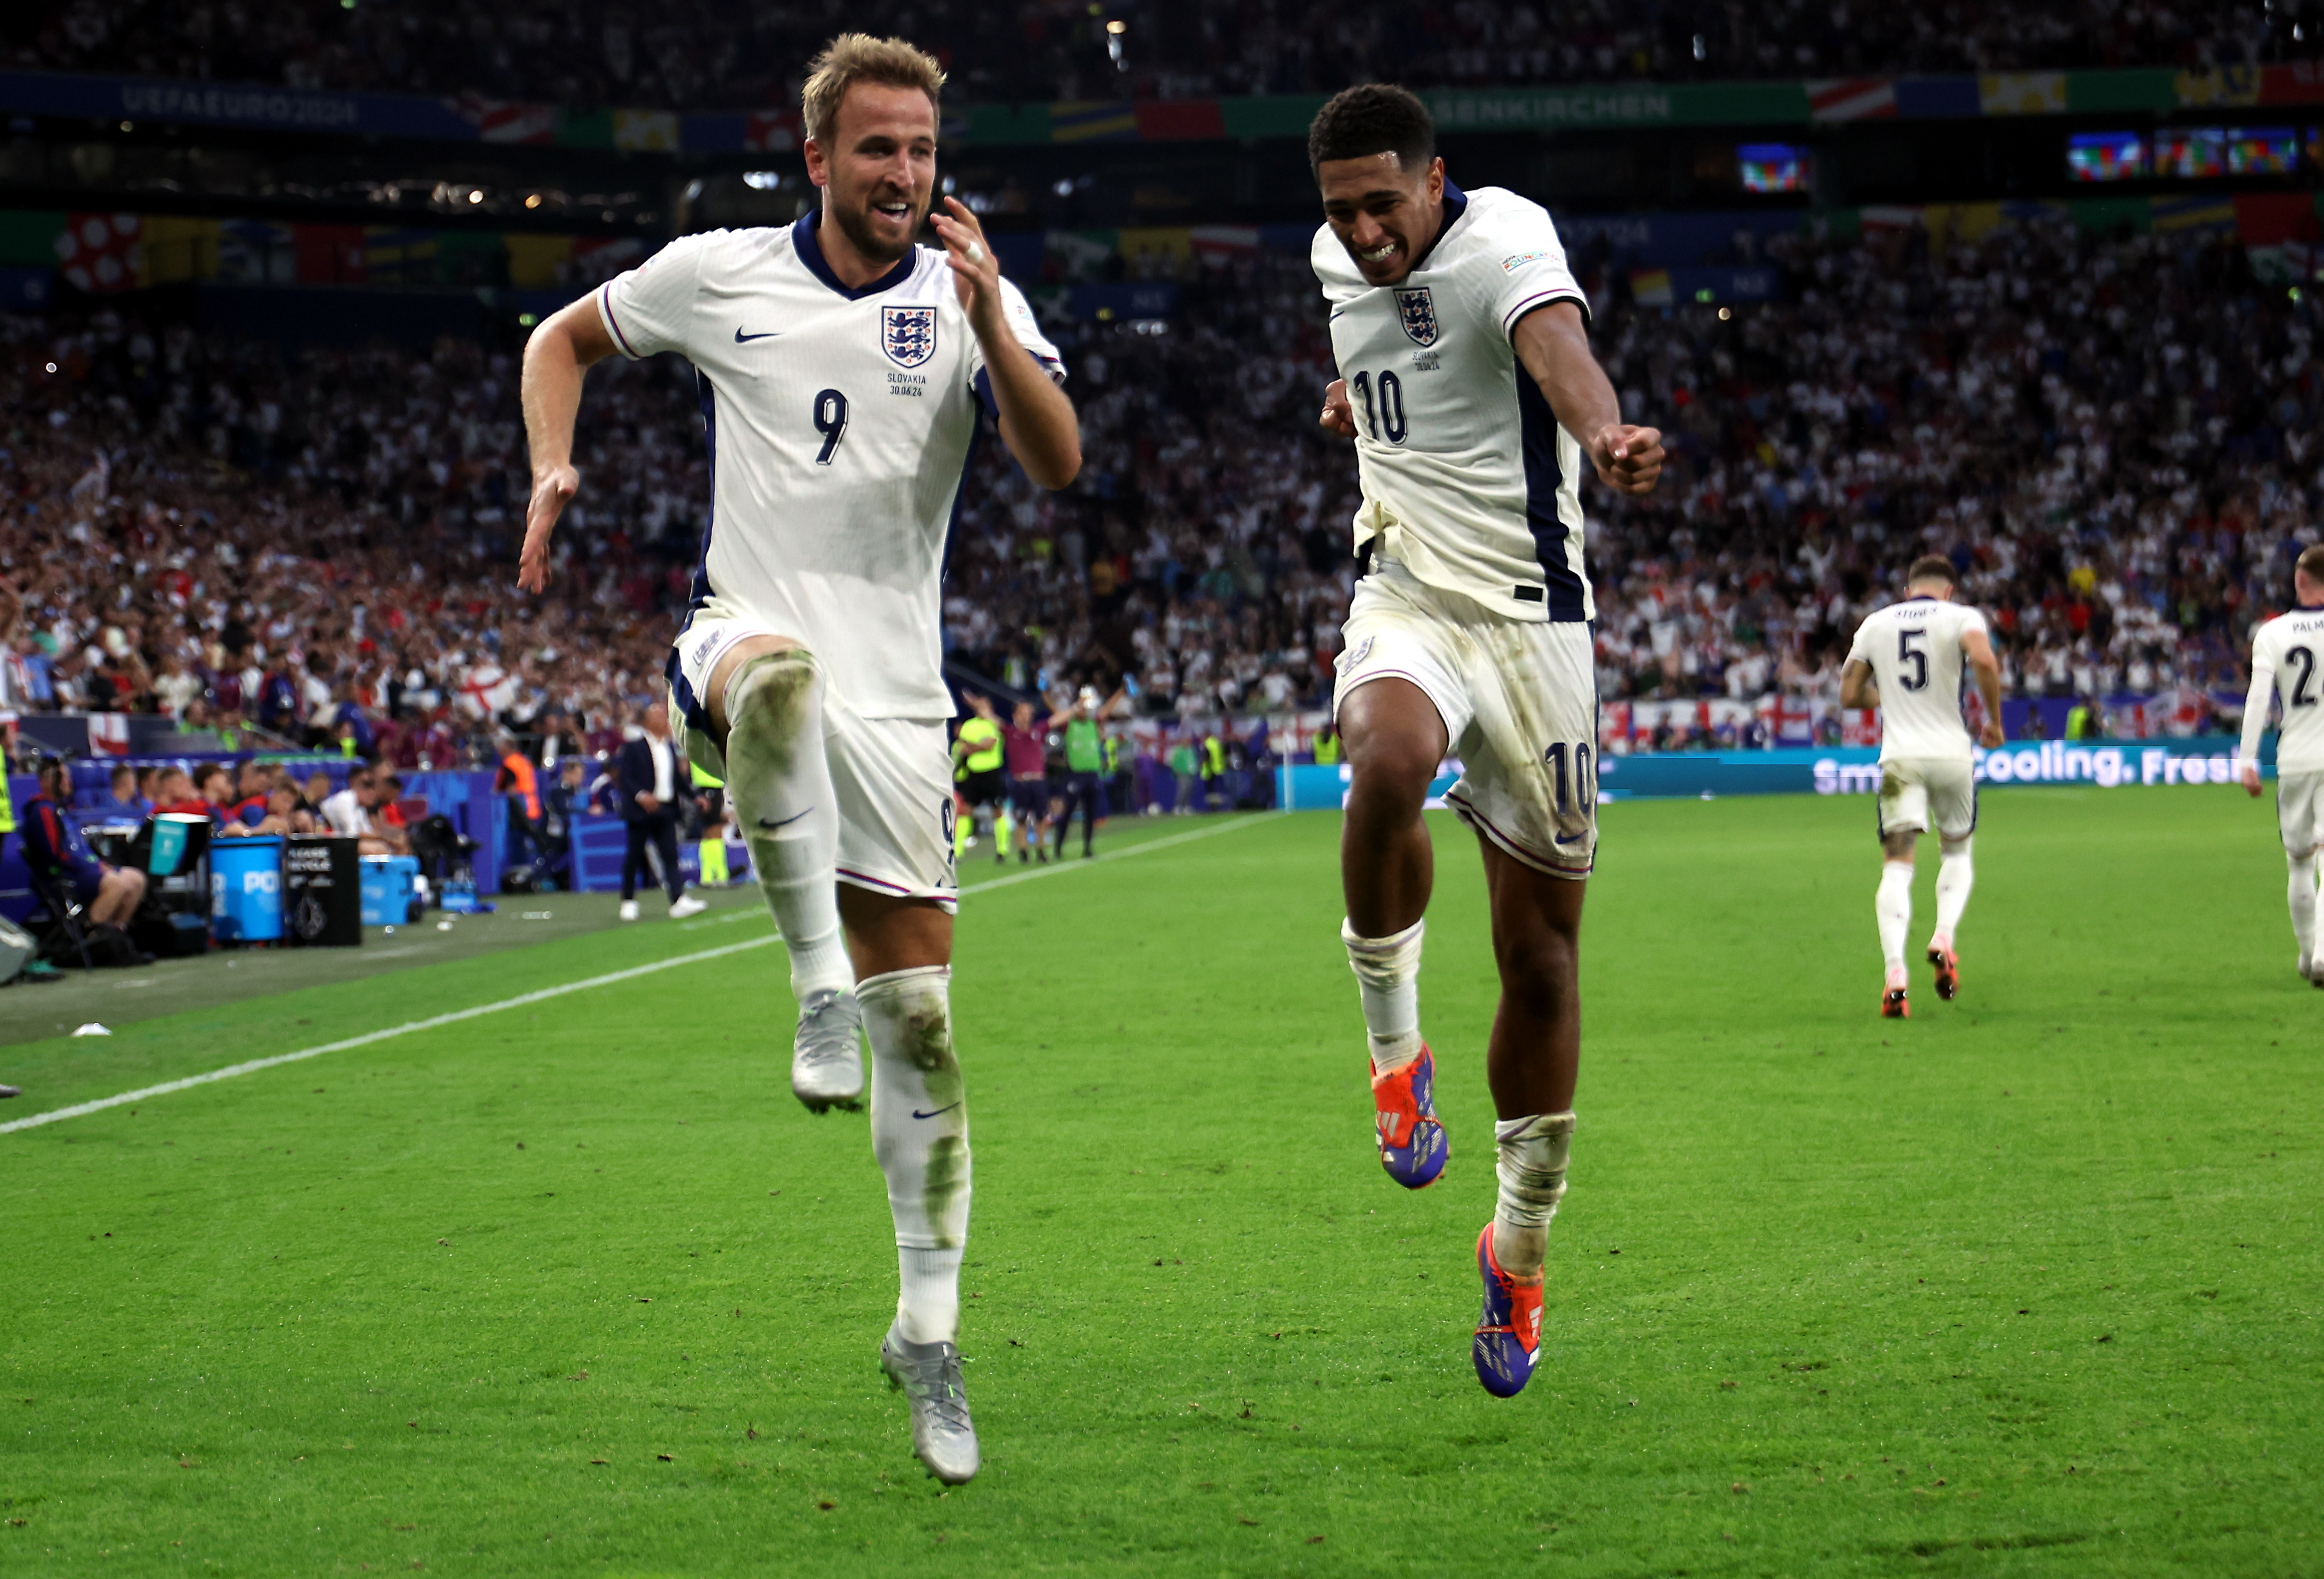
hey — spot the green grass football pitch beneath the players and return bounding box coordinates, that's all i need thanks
[0,790,2324,1575]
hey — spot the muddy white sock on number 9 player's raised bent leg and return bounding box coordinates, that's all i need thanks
[725,648,855,1001]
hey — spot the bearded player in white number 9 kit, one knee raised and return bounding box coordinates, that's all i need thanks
[520,35,1081,1484]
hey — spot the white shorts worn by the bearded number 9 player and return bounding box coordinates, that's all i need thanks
[669,597,960,910]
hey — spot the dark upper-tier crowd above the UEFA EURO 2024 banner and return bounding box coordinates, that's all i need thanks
[0,0,2277,109]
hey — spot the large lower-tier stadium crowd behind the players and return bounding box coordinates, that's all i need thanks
[0,218,2324,769]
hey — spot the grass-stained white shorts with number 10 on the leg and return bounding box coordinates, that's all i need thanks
[1331,555,1597,878]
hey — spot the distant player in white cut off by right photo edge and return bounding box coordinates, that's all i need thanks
[2236,543,2324,987]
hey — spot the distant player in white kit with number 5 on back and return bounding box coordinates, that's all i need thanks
[1840,555,2001,1019]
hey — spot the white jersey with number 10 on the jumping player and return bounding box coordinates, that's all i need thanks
[1311,181,1597,620]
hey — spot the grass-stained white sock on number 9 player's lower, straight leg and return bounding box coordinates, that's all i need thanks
[855,966,969,1342]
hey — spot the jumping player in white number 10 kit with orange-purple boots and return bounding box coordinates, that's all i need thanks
[1309,84,1661,1398]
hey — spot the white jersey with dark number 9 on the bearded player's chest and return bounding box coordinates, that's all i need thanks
[597,209,1064,718]
